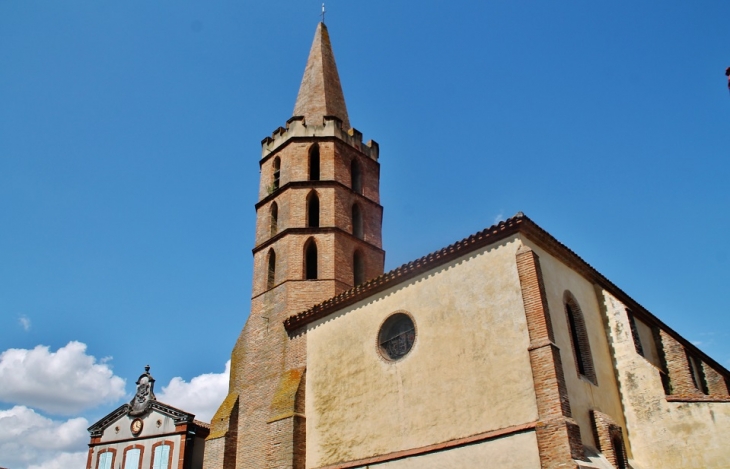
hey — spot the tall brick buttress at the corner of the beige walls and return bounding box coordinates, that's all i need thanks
[516,245,585,469]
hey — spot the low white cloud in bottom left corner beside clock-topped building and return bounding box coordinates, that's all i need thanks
[0,406,89,469]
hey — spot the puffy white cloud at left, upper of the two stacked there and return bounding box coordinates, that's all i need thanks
[0,341,124,415]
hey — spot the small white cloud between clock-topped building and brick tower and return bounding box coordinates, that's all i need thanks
[157,360,231,422]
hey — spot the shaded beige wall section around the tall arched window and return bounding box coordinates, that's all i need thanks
[524,238,631,455]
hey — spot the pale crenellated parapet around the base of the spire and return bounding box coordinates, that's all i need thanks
[261,116,380,161]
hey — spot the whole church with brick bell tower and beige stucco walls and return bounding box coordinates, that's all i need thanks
[200,23,730,469]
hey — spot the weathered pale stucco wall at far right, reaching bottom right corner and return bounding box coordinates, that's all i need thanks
[600,291,730,469]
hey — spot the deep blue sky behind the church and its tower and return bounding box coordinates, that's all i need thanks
[0,0,730,469]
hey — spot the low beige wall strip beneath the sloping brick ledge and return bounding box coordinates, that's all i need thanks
[362,432,540,469]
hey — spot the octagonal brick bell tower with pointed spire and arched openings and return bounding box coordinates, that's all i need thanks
[204,23,385,469]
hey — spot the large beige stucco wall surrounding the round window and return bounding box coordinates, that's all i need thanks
[306,238,537,468]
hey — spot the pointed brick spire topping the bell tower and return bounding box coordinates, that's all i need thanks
[294,23,350,129]
